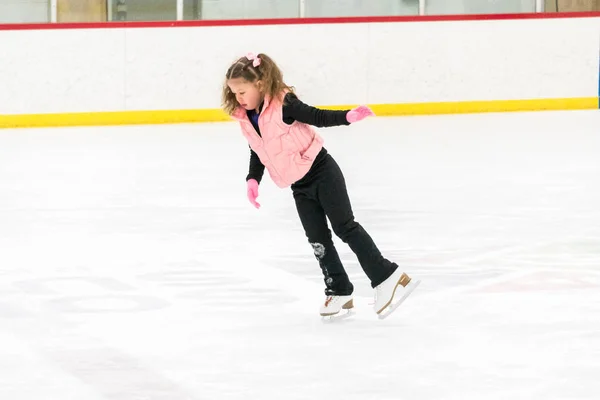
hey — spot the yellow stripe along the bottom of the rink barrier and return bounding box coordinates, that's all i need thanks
[0,97,599,128]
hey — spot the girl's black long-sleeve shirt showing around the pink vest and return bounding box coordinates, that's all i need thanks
[246,93,350,183]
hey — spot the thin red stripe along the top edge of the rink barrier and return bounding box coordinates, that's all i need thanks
[0,11,600,31]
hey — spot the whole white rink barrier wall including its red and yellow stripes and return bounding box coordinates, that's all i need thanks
[0,12,600,128]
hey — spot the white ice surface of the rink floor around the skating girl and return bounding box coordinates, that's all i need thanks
[0,111,600,400]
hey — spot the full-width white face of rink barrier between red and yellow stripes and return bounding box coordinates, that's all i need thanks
[0,18,600,114]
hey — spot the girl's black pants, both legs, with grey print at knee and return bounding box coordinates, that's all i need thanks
[292,149,398,295]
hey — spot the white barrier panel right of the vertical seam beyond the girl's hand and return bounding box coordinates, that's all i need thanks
[368,19,600,104]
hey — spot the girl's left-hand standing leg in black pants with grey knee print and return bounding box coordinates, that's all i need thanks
[293,187,354,296]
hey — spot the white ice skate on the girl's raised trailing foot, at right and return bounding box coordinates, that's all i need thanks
[373,269,421,319]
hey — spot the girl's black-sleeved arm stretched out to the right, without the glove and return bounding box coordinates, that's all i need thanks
[283,93,350,128]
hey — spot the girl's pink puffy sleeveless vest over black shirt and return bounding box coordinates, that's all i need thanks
[233,93,323,188]
